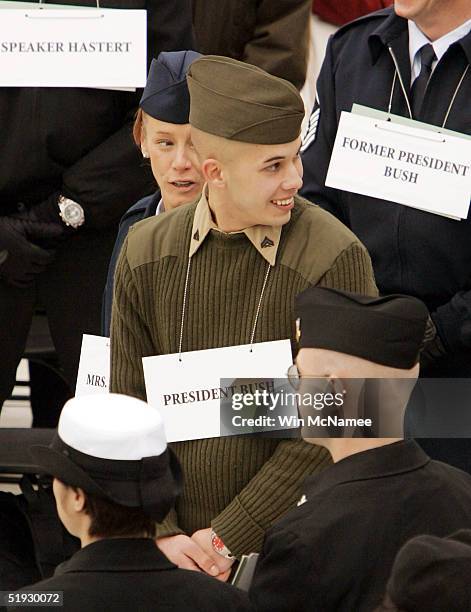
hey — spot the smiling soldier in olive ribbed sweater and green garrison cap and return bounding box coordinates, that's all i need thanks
[111,56,377,580]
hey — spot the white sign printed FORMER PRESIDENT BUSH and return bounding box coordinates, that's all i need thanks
[326,112,471,219]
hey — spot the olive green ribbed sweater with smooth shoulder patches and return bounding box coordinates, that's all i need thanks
[111,198,377,555]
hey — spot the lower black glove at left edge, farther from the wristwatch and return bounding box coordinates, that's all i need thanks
[0,217,54,288]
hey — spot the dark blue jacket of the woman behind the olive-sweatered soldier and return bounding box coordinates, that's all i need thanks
[101,189,160,336]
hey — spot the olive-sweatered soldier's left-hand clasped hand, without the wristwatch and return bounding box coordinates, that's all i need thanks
[155,534,219,577]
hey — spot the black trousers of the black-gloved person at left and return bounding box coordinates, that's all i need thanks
[0,226,117,407]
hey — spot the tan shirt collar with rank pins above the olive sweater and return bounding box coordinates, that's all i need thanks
[189,189,281,266]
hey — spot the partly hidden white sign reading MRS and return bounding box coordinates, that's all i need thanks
[75,334,110,397]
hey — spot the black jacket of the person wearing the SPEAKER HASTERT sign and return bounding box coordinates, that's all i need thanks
[0,0,193,232]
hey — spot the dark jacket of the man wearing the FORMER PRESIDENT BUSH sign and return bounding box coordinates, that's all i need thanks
[301,9,471,376]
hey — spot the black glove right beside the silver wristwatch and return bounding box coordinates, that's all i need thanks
[10,193,70,246]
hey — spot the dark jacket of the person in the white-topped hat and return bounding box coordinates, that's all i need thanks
[13,538,251,612]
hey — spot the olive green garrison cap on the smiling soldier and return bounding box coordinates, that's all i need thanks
[187,55,304,144]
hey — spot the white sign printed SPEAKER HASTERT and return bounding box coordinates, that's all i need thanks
[0,3,147,89]
